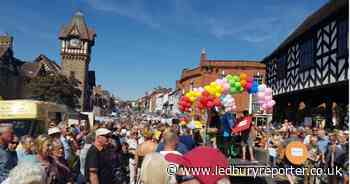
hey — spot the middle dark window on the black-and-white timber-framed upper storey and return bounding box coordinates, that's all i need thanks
[300,39,315,71]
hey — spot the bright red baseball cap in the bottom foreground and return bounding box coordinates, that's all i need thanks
[165,146,229,184]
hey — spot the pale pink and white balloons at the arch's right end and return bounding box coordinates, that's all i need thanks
[258,84,276,112]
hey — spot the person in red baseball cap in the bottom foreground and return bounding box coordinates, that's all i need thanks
[165,146,231,184]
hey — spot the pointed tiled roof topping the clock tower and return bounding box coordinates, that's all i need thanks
[59,11,96,41]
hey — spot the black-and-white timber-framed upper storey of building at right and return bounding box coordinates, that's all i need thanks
[263,0,349,120]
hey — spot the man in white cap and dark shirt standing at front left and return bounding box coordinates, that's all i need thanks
[85,128,112,184]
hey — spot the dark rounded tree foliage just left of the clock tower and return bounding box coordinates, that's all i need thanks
[28,74,81,109]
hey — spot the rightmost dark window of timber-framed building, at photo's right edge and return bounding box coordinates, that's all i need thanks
[337,20,349,57]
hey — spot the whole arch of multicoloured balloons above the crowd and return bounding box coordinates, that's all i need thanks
[179,73,276,112]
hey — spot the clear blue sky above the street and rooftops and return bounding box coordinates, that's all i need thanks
[0,0,327,100]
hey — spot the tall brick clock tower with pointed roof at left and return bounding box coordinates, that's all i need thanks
[59,11,96,111]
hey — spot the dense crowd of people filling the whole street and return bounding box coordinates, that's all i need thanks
[0,105,349,184]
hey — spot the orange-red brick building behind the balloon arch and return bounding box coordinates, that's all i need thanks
[176,50,265,113]
